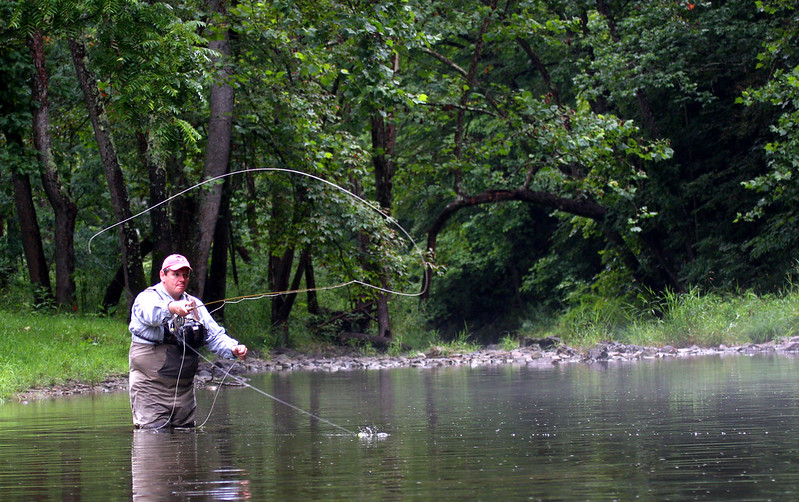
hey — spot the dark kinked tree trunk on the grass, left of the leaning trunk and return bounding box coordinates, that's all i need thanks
[28,31,78,309]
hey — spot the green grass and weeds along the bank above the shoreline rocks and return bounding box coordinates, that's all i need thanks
[0,289,799,400]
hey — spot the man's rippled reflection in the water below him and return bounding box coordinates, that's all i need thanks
[130,429,251,502]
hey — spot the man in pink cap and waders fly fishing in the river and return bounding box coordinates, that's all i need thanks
[128,254,247,429]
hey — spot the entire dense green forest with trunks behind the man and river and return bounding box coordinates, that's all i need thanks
[0,0,799,354]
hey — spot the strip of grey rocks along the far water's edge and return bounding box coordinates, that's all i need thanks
[17,337,799,402]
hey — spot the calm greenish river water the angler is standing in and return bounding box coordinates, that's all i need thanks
[0,355,799,501]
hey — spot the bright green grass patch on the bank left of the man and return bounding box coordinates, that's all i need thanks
[0,312,130,402]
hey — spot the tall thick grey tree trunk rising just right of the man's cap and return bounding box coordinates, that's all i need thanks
[193,0,234,296]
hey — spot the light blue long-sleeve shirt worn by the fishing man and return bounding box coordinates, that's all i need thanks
[128,282,239,359]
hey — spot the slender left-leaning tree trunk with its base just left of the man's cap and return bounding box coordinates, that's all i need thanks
[67,37,144,311]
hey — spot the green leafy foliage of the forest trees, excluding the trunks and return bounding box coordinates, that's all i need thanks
[0,0,799,350]
